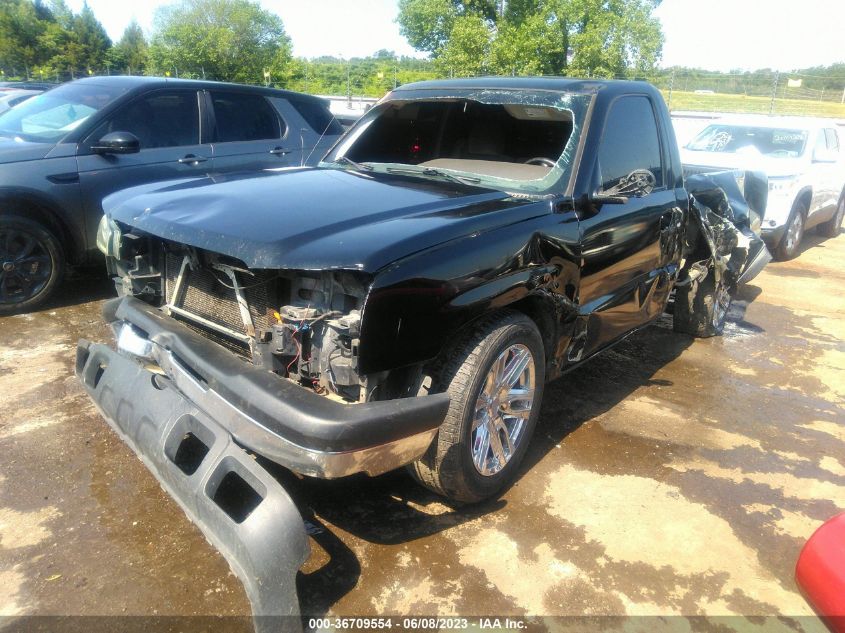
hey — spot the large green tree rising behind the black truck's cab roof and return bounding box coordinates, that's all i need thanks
[397,0,663,77]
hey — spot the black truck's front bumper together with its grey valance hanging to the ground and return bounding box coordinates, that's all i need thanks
[76,297,449,631]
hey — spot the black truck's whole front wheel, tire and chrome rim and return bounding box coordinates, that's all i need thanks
[410,312,545,502]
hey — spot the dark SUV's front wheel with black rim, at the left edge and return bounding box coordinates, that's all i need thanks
[0,215,65,315]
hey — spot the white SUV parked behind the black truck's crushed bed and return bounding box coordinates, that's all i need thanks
[681,115,845,260]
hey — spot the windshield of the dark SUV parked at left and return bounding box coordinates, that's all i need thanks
[0,83,124,143]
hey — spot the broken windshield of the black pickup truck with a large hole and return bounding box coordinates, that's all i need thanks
[322,91,592,194]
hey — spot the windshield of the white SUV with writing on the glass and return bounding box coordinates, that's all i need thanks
[687,125,808,158]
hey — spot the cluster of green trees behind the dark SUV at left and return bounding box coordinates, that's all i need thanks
[0,0,292,83]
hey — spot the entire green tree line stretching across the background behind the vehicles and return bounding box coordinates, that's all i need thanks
[0,0,845,99]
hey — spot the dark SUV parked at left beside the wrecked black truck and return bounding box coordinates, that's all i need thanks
[0,77,342,314]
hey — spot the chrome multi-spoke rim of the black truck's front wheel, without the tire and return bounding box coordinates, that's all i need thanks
[470,344,536,477]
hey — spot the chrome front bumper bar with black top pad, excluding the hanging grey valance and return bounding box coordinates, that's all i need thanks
[89,297,449,479]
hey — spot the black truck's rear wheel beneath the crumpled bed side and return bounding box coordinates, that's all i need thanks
[672,267,732,338]
